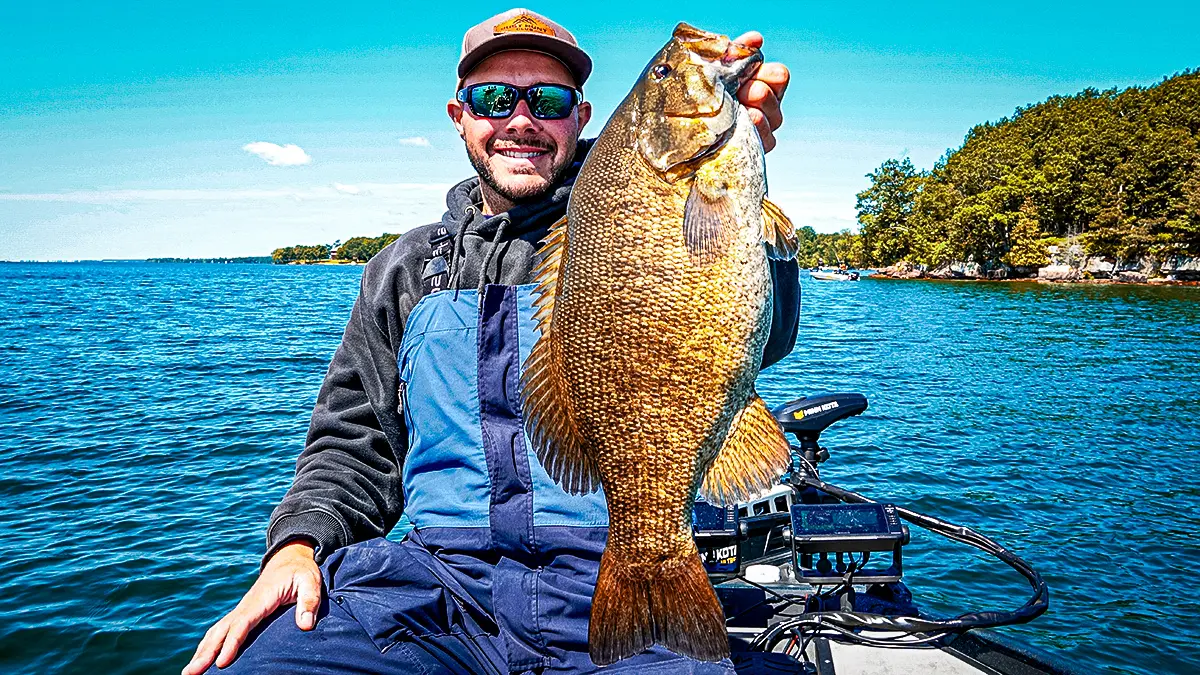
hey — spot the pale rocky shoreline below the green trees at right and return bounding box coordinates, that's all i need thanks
[870,257,1200,286]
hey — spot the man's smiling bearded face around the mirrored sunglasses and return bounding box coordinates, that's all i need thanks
[446,50,592,203]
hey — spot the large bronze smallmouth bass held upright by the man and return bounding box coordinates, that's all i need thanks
[522,24,797,665]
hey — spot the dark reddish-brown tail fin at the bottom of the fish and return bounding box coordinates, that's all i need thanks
[588,550,730,665]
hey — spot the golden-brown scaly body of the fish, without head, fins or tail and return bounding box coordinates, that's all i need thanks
[566,107,770,561]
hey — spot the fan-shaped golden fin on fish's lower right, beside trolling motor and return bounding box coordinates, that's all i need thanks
[700,394,792,504]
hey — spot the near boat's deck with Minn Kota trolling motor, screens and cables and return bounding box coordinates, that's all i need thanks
[692,393,1072,675]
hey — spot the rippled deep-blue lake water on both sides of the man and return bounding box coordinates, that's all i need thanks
[0,263,1200,675]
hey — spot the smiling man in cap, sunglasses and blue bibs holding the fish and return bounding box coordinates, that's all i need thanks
[184,10,799,675]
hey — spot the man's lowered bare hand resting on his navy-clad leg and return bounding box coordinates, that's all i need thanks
[182,542,320,675]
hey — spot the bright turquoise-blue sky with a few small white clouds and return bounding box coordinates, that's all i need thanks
[0,0,1200,261]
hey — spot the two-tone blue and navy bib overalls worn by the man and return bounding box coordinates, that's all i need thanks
[212,285,733,675]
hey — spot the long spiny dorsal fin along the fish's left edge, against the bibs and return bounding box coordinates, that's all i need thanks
[521,216,600,495]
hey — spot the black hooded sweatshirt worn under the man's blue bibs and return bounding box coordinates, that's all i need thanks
[263,142,800,565]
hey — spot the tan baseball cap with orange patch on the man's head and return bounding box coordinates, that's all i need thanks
[458,7,592,86]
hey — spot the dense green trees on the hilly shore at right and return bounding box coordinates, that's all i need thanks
[842,71,1200,270]
